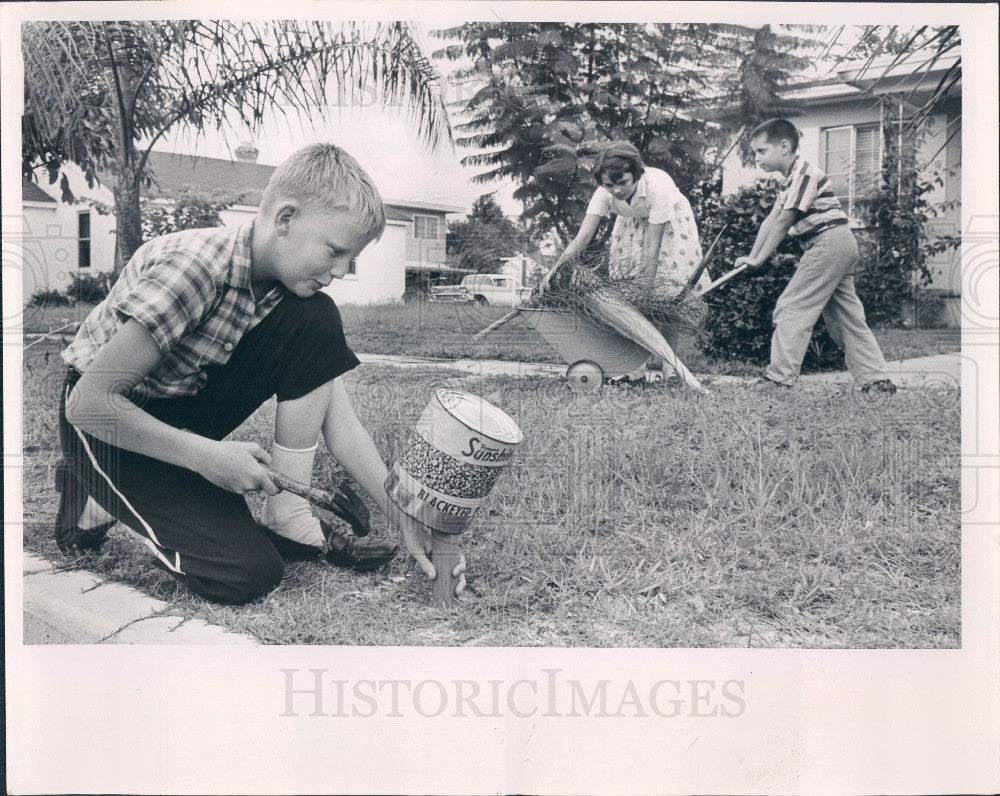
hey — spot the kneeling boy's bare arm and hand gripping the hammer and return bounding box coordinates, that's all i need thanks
[66,319,278,495]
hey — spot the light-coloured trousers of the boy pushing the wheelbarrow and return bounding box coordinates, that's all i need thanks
[766,225,885,385]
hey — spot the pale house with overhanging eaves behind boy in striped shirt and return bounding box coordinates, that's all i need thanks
[722,54,962,326]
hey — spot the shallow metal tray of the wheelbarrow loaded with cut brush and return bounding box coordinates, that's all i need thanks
[520,307,650,378]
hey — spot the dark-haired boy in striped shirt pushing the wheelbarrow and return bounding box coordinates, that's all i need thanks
[736,119,896,393]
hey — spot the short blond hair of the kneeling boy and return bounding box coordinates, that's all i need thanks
[260,144,385,238]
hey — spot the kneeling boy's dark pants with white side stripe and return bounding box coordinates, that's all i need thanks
[57,294,356,604]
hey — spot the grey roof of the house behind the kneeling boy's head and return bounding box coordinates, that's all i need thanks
[146,151,461,215]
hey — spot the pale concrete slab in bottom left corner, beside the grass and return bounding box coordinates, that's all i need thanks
[24,552,258,645]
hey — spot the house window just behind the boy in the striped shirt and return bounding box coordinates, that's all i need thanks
[820,124,882,218]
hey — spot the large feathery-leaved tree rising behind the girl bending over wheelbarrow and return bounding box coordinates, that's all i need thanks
[435,22,816,242]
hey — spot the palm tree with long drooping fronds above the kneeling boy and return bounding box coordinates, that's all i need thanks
[21,20,451,272]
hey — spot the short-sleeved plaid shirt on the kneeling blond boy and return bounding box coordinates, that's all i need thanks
[62,224,285,398]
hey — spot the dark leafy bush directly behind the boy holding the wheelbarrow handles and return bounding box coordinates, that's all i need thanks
[693,179,843,371]
